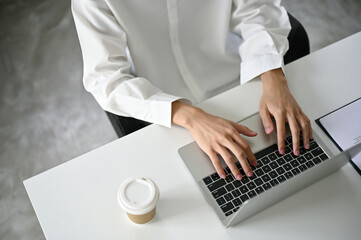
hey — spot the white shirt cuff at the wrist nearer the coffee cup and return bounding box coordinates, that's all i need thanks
[151,92,192,128]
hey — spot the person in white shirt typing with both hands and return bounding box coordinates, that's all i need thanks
[72,0,312,180]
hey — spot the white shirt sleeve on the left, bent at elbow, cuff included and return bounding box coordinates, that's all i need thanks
[71,0,187,127]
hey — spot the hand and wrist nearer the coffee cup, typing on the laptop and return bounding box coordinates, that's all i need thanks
[172,101,257,180]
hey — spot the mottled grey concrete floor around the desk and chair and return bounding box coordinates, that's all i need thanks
[0,0,361,240]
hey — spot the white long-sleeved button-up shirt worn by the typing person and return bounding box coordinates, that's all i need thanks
[72,0,291,127]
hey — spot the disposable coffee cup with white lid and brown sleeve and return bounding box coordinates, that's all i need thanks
[118,177,159,224]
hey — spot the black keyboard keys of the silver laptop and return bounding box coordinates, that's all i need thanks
[203,136,329,216]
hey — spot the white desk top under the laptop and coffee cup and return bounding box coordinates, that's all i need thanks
[24,33,361,240]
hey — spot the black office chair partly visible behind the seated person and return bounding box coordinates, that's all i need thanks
[106,13,310,138]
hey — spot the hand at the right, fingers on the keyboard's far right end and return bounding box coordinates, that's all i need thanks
[259,68,312,156]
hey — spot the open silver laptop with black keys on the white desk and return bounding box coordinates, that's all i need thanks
[178,113,361,227]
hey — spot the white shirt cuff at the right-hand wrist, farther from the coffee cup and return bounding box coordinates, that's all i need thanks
[240,54,284,85]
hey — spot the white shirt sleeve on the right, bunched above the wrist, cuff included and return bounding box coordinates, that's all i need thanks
[230,0,291,84]
